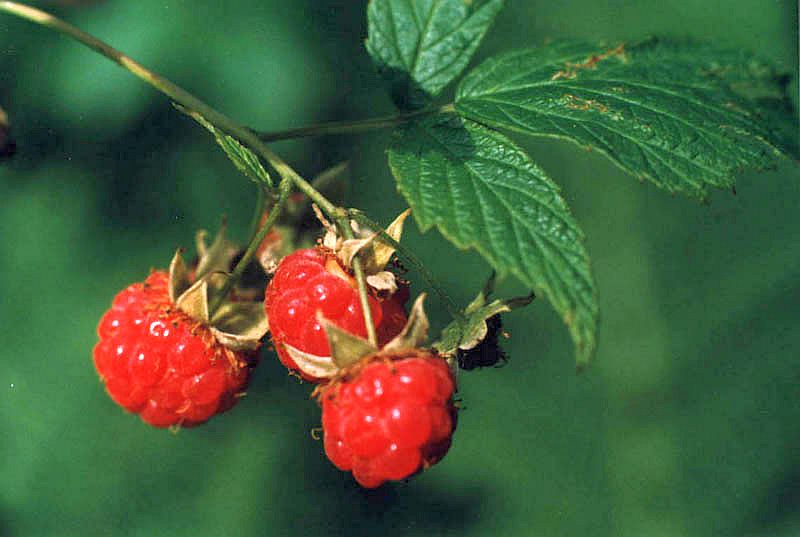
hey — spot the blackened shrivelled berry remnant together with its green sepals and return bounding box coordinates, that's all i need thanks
[433,274,535,369]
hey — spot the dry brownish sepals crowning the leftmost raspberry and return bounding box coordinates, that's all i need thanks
[169,225,269,351]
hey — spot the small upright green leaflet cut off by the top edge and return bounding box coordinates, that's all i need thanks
[366,0,504,109]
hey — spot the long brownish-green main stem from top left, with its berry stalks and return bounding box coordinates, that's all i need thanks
[0,1,377,343]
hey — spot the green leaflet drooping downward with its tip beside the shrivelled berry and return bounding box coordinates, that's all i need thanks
[389,116,598,367]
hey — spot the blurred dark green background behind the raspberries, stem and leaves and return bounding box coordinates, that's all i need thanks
[0,0,800,537]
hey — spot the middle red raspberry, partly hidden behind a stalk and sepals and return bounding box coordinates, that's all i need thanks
[264,249,408,381]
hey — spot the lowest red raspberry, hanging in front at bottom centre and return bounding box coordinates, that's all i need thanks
[320,351,456,488]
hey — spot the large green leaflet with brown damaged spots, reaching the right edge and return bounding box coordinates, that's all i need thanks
[456,39,798,198]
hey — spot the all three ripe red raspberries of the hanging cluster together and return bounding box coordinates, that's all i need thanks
[94,248,456,488]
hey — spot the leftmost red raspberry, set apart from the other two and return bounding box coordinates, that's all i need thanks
[94,272,251,427]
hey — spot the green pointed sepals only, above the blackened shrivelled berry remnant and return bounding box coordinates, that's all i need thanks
[433,273,535,356]
